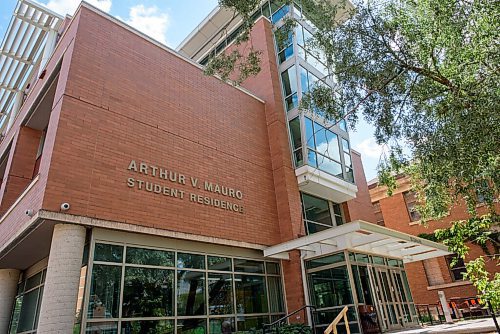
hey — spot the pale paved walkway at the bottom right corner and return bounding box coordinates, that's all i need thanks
[390,318,498,334]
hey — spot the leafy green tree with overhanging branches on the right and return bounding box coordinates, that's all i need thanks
[208,0,500,306]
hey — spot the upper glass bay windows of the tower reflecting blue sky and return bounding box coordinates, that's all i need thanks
[200,0,354,183]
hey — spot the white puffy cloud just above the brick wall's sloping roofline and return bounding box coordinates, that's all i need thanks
[124,5,170,44]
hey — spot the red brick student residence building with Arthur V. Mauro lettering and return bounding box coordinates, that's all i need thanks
[0,0,447,334]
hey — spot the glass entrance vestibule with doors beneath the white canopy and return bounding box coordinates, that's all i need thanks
[306,251,417,333]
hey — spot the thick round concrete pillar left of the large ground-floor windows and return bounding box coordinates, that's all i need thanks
[37,224,85,334]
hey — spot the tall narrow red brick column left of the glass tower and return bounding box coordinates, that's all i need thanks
[237,18,306,314]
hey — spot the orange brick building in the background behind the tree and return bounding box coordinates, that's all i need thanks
[369,175,497,312]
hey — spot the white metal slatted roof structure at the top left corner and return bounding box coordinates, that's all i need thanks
[0,0,63,135]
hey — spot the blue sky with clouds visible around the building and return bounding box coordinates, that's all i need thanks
[0,0,382,180]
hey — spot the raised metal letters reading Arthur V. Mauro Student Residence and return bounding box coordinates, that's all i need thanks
[127,160,244,213]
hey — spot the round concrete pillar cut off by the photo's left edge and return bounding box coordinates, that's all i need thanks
[0,269,19,333]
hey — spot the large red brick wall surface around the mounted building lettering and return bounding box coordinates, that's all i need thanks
[43,8,279,245]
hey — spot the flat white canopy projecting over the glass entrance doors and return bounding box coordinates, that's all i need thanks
[264,220,451,263]
